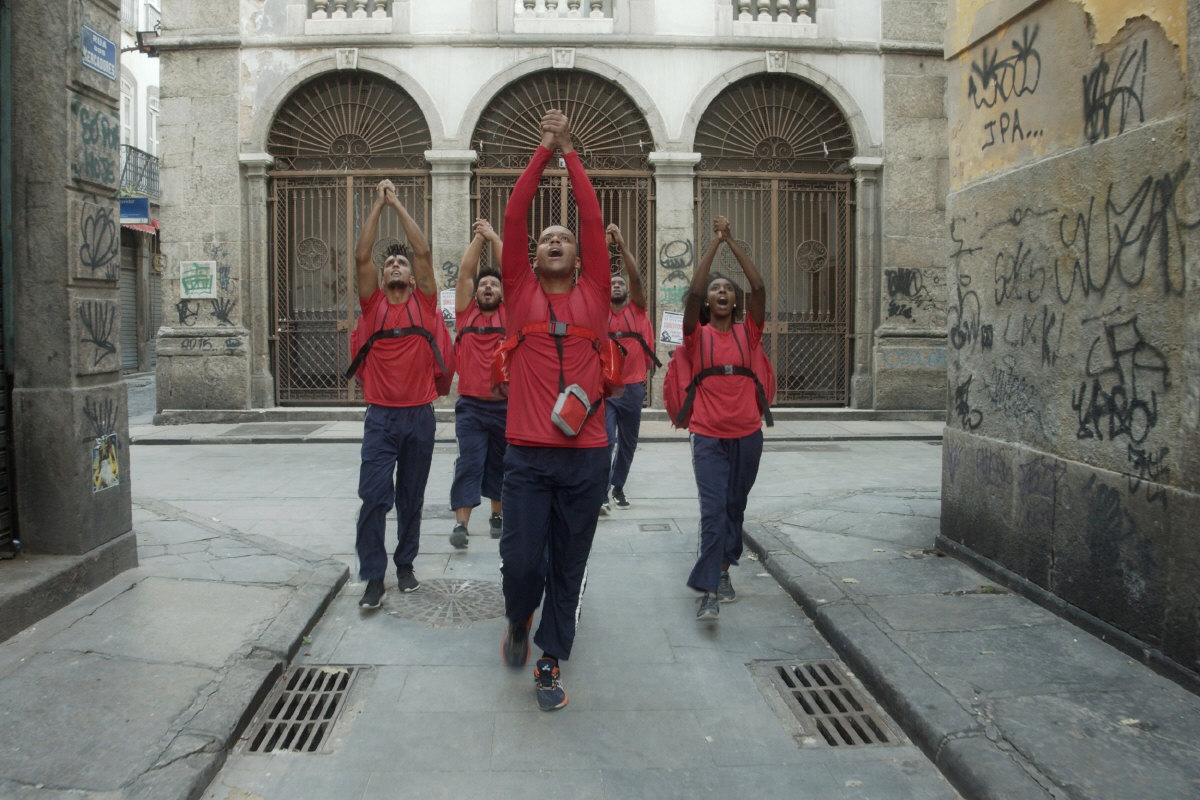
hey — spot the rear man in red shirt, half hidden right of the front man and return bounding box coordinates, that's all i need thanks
[600,223,662,513]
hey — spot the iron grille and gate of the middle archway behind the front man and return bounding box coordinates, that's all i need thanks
[472,70,658,404]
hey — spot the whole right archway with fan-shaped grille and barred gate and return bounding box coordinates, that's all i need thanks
[695,74,854,405]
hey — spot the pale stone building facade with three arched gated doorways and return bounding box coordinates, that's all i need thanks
[156,0,948,419]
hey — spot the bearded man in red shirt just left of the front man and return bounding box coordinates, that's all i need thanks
[450,219,509,548]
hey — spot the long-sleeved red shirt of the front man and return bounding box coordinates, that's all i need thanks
[502,146,612,447]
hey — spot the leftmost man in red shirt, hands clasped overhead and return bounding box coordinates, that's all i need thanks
[354,180,444,609]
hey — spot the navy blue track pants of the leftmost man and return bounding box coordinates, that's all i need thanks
[356,403,434,581]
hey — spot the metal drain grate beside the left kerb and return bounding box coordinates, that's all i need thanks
[246,667,359,753]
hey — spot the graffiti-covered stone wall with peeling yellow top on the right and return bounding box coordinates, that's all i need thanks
[942,0,1200,680]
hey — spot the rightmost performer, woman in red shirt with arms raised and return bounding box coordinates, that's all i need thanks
[683,217,767,620]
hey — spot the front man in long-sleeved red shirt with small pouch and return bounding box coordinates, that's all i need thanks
[499,109,610,711]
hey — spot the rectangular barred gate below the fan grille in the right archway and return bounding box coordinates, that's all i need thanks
[696,175,851,405]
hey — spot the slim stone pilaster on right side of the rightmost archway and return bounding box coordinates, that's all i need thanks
[850,157,883,408]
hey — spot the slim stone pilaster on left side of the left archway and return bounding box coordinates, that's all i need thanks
[238,152,275,408]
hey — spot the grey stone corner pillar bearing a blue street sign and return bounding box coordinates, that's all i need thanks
[5,1,137,575]
